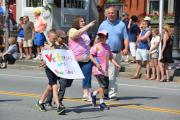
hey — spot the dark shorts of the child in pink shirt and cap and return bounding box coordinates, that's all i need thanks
[95,75,109,88]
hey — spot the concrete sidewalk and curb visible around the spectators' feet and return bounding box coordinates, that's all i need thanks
[8,60,180,82]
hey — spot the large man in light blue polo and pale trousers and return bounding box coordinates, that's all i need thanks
[98,6,129,98]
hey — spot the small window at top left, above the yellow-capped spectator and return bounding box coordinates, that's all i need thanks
[26,0,43,7]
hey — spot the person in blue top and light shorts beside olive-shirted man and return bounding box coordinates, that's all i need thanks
[17,17,24,59]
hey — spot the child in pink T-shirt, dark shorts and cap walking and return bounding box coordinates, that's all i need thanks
[90,31,120,110]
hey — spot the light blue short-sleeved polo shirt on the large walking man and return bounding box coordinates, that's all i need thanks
[98,19,128,52]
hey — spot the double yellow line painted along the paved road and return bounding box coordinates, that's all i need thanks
[0,91,180,115]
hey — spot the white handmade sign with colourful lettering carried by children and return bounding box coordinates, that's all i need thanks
[42,49,84,79]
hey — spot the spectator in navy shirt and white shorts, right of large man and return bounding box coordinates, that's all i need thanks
[128,16,140,63]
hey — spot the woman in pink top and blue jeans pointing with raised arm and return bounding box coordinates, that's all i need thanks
[68,16,95,100]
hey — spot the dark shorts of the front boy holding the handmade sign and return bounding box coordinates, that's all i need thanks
[45,66,58,85]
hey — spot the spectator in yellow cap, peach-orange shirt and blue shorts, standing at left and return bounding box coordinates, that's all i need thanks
[34,9,47,59]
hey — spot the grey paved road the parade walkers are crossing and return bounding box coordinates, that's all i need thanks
[0,68,180,120]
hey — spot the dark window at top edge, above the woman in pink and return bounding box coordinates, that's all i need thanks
[64,0,86,9]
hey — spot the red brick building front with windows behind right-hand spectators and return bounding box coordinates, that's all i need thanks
[98,0,175,24]
